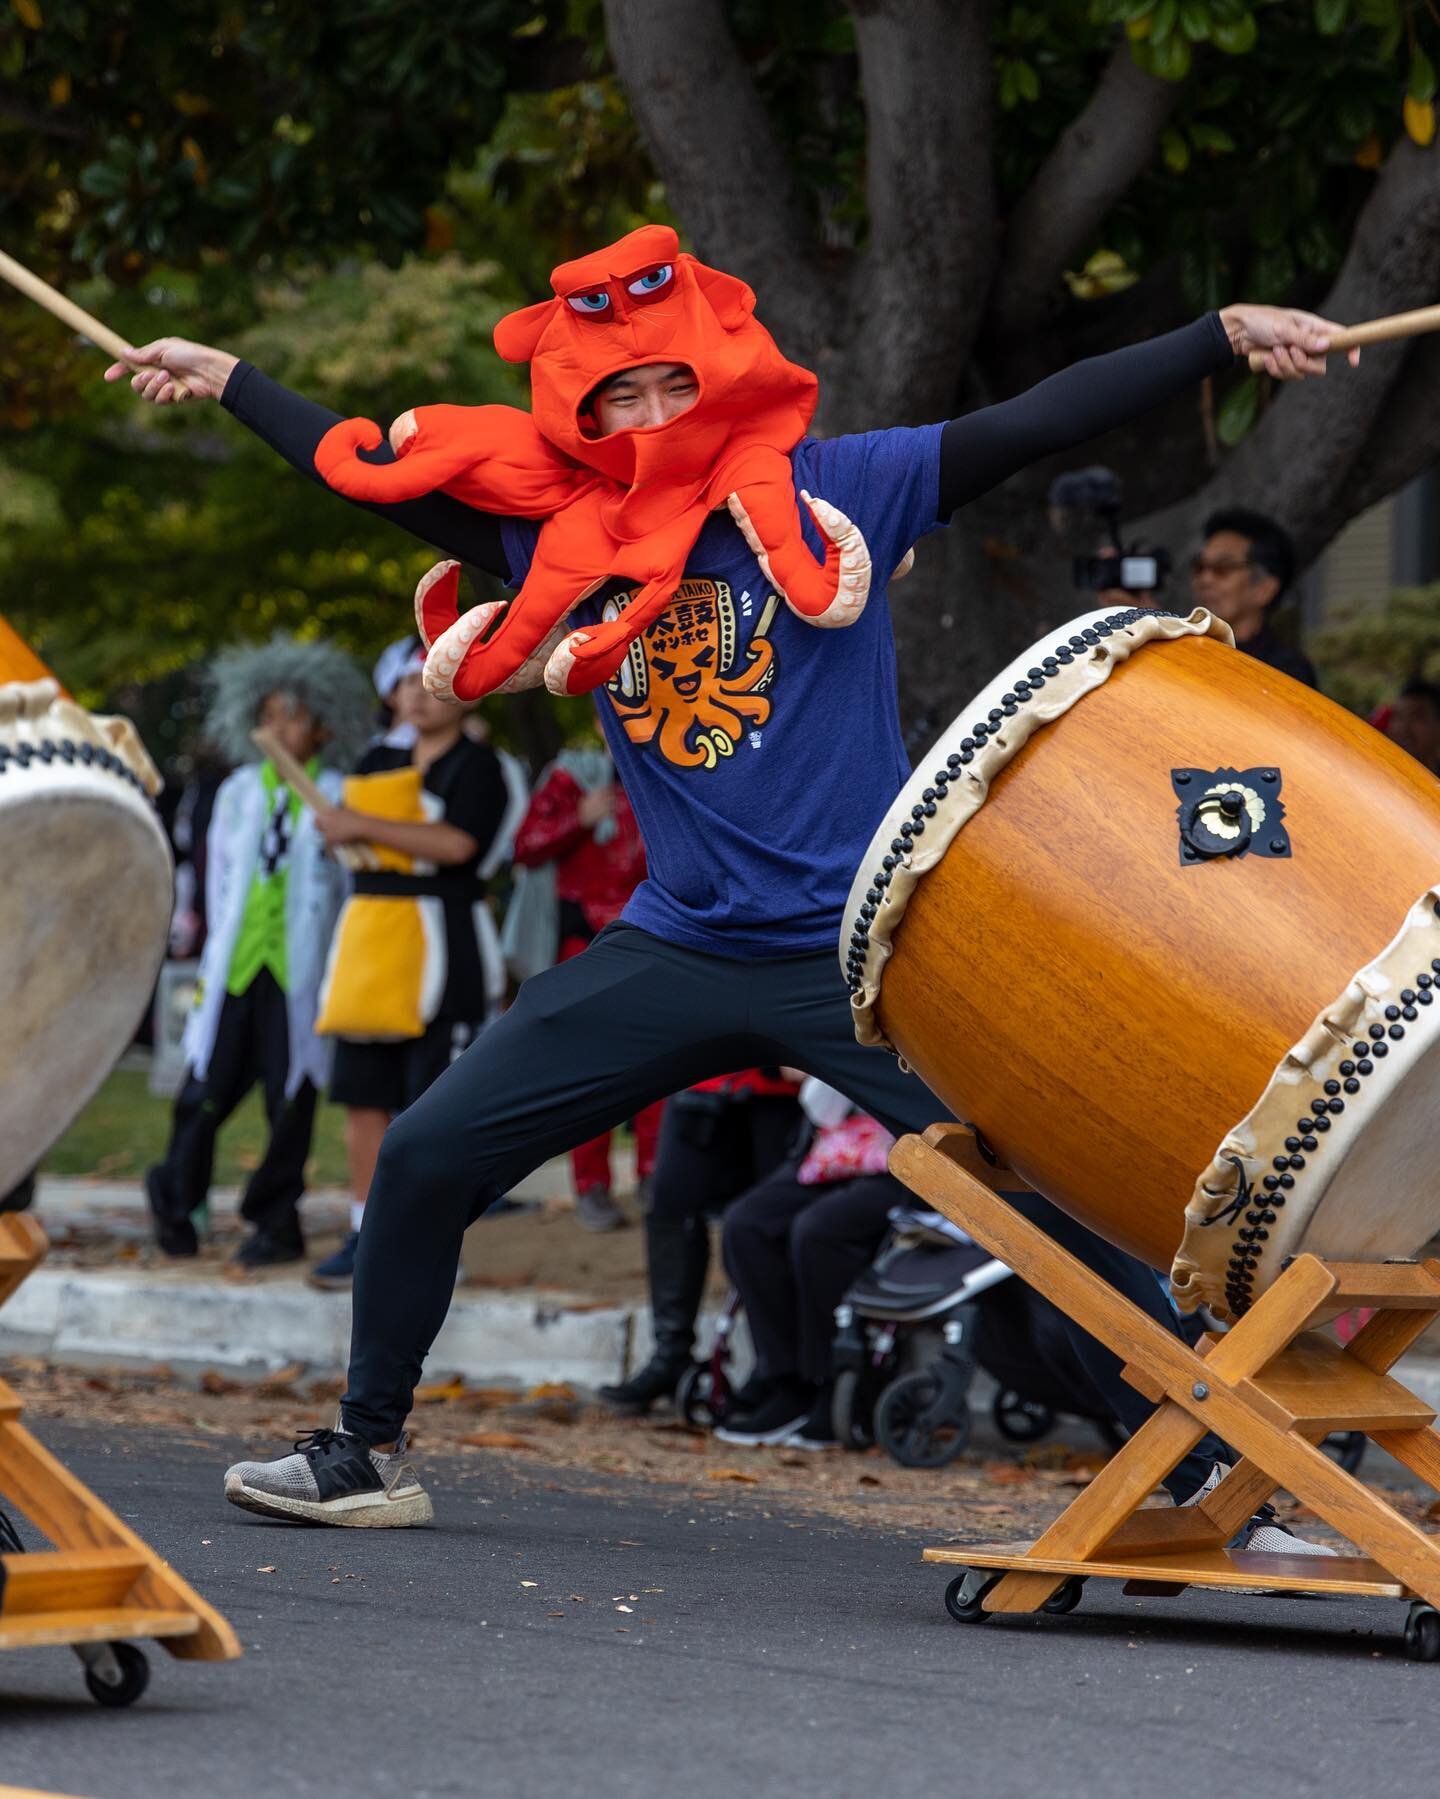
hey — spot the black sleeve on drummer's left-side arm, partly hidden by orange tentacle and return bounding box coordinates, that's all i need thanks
[220,362,509,581]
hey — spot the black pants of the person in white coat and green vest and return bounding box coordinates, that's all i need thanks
[149,968,315,1241]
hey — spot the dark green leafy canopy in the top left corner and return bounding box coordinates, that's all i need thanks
[0,0,568,277]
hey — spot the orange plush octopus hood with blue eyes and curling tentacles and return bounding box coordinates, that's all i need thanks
[315,225,869,700]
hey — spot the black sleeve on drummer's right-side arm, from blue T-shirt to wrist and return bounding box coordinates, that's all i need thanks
[938,313,1235,518]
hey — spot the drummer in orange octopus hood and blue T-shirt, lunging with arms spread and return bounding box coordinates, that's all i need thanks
[112,227,1334,1553]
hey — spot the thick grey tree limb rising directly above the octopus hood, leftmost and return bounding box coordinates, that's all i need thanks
[605,0,839,358]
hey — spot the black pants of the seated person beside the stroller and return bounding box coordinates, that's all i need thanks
[722,1172,900,1383]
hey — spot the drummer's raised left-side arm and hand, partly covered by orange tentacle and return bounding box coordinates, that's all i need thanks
[104,338,509,581]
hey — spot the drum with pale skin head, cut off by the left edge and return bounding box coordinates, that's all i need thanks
[0,628,173,1193]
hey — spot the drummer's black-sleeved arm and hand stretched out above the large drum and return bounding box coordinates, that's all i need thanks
[938,306,1359,518]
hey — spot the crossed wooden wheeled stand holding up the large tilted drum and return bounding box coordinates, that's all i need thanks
[891,1124,1440,1660]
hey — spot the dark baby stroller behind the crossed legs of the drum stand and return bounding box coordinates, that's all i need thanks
[833,1205,1123,1468]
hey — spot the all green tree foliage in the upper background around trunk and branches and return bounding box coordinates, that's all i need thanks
[0,0,1440,712]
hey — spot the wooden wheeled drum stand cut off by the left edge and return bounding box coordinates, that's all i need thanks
[0,1213,239,1705]
